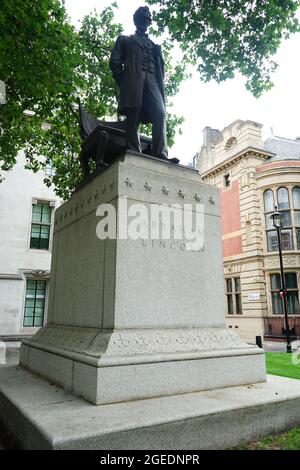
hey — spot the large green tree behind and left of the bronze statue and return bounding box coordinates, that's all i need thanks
[0,0,185,198]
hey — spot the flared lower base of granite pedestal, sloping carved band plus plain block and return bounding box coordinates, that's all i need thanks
[20,325,266,405]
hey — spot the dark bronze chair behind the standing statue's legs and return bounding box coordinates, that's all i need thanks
[78,100,152,176]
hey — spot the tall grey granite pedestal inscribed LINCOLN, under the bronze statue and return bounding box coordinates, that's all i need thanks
[20,153,265,405]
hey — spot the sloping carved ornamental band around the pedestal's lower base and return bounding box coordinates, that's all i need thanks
[34,327,245,358]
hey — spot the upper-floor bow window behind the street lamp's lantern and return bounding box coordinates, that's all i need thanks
[263,186,300,251]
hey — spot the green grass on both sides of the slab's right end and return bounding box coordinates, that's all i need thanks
[237,352,300,450]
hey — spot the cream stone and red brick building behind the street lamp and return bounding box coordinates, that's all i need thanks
[196,120,300,341]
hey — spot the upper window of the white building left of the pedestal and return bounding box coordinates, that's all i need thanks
[30,203,52,250]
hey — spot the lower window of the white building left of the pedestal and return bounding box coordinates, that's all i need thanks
[23,279,46,326]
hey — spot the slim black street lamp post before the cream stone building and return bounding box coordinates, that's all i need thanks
[270,206,292,353]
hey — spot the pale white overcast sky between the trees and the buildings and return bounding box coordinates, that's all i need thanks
[65,0,300,163]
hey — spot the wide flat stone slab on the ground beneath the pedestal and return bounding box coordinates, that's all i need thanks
[0,366,300,450]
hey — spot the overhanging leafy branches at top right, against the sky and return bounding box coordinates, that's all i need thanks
[148,0,300,97]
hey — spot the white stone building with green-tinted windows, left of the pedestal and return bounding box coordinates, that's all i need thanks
[0,153,60,341]
